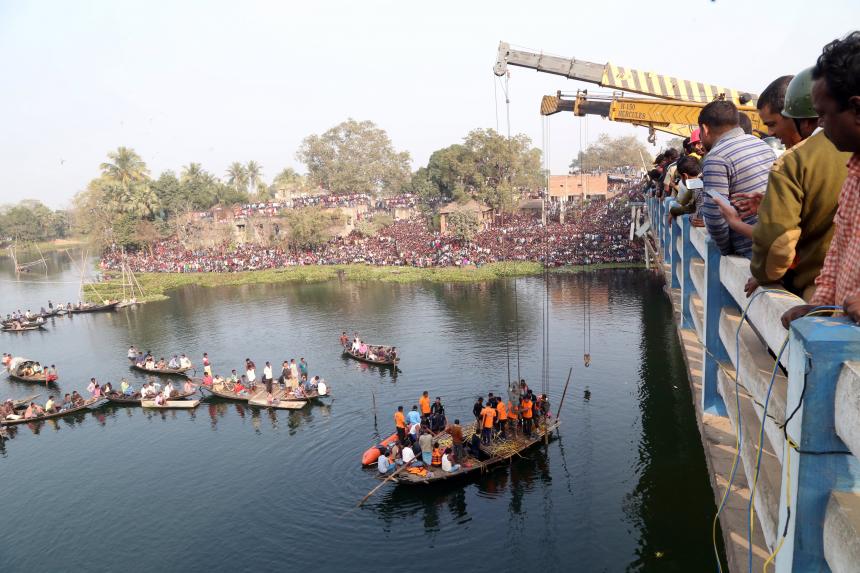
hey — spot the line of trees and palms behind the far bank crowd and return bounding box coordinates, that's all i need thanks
[57,119,638,246]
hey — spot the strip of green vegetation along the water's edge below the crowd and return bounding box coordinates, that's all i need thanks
[86,261,645,302]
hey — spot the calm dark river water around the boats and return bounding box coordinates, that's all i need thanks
[0,255,714,572]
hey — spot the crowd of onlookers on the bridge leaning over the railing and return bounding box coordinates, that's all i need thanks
[646,31,860,325]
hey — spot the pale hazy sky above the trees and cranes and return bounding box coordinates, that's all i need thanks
[0,0,857,207]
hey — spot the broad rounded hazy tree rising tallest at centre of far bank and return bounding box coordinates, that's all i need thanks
[296,119,410,194]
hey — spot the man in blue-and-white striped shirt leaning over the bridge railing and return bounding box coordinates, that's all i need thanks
[699,100,775,258]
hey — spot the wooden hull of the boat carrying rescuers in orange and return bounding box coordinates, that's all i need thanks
[386,420,559,485]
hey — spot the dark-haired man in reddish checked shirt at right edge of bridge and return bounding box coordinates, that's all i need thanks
[782,32,860,328]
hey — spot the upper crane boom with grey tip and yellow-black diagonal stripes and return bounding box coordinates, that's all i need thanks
[493,42,758,105]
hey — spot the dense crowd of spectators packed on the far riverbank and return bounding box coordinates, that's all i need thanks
[101,199,642,272]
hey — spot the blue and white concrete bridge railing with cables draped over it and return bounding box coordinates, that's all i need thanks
[648,194,860,572]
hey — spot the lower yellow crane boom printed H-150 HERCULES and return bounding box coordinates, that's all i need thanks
[540,91,767,143]
